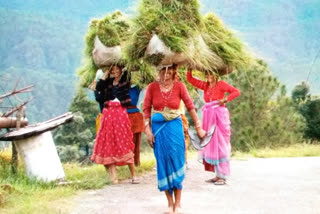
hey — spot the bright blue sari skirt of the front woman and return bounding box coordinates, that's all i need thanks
[151,113,185,194]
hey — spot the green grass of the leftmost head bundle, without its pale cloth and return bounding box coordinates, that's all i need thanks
[78,11,130,87]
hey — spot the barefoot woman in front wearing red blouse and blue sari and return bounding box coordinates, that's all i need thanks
[143,66,205,213]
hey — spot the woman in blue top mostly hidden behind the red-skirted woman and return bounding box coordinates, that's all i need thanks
[127,85,144,166]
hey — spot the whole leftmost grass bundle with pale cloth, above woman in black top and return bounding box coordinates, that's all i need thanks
[78,11,130,87]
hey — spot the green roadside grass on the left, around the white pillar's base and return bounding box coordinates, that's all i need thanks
[0,150,155,214]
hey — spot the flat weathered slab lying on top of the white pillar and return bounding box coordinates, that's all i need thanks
[0,112,73,141]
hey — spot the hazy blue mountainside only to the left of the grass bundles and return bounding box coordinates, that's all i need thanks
[0,0,132,123]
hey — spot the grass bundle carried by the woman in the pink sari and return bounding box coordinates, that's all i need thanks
[202,13,251,75]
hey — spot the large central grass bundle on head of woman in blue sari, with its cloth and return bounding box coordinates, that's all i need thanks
[126,0,221,69]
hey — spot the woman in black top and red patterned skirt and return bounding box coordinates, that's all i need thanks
[91,65,139,184]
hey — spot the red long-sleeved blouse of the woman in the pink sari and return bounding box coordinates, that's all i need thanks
[187,72,240,102]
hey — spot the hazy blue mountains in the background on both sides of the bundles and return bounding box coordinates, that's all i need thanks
[0,0,320,121]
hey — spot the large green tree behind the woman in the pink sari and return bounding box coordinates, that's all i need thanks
[227,61,305,151]
